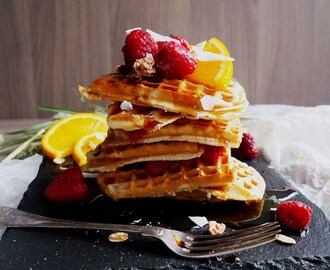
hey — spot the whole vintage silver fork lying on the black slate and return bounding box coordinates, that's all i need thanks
[0,207,281,259]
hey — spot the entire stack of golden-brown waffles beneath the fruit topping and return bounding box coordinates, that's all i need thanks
[80,73,265,202]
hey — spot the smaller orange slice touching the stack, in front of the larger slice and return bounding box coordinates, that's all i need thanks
[72,133,107,166]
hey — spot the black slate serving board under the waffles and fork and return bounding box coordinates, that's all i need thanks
[0,159,330,269]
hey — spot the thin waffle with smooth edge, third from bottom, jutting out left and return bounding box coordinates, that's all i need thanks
[87,141,204,172]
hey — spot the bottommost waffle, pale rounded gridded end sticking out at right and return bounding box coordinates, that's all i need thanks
[175,158,266,203]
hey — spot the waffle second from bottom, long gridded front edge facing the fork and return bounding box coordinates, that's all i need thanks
[97,159,235,200]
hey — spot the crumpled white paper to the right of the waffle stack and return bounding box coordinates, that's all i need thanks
[243,105,330,218]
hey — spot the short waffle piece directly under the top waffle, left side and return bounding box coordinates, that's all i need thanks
[107,102,181,132]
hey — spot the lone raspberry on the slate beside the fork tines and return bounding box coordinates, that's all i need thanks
[276,201,313,232]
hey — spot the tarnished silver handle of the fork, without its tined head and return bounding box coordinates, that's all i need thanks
[0,206,160,235]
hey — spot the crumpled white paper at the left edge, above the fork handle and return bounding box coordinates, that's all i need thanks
[0,154,42,239]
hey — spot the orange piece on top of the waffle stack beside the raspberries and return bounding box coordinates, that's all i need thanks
[187,37,234,89]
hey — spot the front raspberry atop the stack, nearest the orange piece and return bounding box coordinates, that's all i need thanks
[155,41,196,79]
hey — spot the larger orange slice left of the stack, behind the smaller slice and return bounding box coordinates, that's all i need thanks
[41,113,108,159]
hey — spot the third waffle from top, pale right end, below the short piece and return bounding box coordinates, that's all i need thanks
[107,118,242,148]
